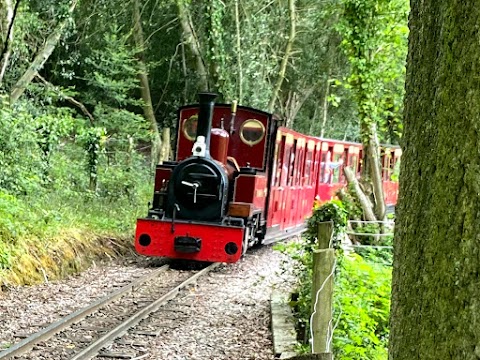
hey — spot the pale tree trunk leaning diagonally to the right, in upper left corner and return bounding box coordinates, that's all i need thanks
[10,0,78,104]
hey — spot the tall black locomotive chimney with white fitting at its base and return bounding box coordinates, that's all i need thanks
[193,93,218,157]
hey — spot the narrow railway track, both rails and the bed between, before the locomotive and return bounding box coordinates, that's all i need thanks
[0,263,218,360]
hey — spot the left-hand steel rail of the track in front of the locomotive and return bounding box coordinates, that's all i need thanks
[0,265,169,359]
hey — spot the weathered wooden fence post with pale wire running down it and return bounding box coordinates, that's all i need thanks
[310,249,335,354]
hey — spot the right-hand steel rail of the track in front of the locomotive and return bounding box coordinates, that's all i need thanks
[70,263,220,360]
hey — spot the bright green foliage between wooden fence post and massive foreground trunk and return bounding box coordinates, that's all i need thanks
[333,255,391,360]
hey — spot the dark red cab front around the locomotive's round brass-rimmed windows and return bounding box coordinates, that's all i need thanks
[176,105,272,170]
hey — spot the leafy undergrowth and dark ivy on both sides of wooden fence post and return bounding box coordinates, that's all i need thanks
[276,200,392,360]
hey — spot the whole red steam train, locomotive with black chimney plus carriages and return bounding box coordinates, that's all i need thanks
[135,93,400,262]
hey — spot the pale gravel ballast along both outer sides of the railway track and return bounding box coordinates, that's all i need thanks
[0,246,294,360]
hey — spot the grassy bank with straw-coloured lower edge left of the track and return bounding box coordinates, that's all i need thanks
[0,182,151,285]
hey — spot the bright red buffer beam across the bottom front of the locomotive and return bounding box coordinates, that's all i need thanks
[135,219,244,262]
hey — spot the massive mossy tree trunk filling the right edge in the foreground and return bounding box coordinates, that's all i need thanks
[389,0,480,360]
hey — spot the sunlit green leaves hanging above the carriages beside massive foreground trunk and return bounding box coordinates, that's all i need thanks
[337,0,409,143]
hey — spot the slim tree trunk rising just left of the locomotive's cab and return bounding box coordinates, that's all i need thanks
[132,0,165,167]
